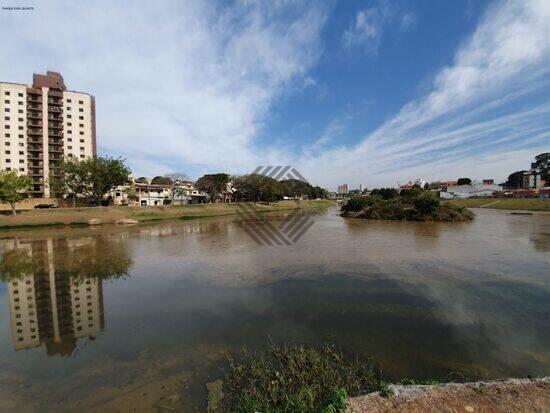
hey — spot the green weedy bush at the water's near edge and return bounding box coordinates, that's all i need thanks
[222,343,387,413]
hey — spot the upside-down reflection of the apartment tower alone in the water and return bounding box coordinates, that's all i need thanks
[6,238,104,356]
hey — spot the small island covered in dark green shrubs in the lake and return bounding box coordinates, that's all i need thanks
[341,188,474,222]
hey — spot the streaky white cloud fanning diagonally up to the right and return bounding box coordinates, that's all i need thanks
[300,0,550,186]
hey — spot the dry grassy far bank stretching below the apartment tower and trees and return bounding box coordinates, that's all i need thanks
[0,200,334,230]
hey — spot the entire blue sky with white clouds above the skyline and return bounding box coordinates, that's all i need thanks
[0,0,550,189]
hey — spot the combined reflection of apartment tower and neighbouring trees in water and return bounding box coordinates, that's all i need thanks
[0,233,132,356]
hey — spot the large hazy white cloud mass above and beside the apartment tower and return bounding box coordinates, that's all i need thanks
[0,0,326,174]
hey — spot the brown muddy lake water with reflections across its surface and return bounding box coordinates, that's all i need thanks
[0,209,550,412]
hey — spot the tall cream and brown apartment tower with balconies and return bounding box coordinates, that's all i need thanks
[0,71,96,198]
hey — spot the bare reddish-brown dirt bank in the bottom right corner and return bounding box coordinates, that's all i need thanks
[348,377,550,413]
